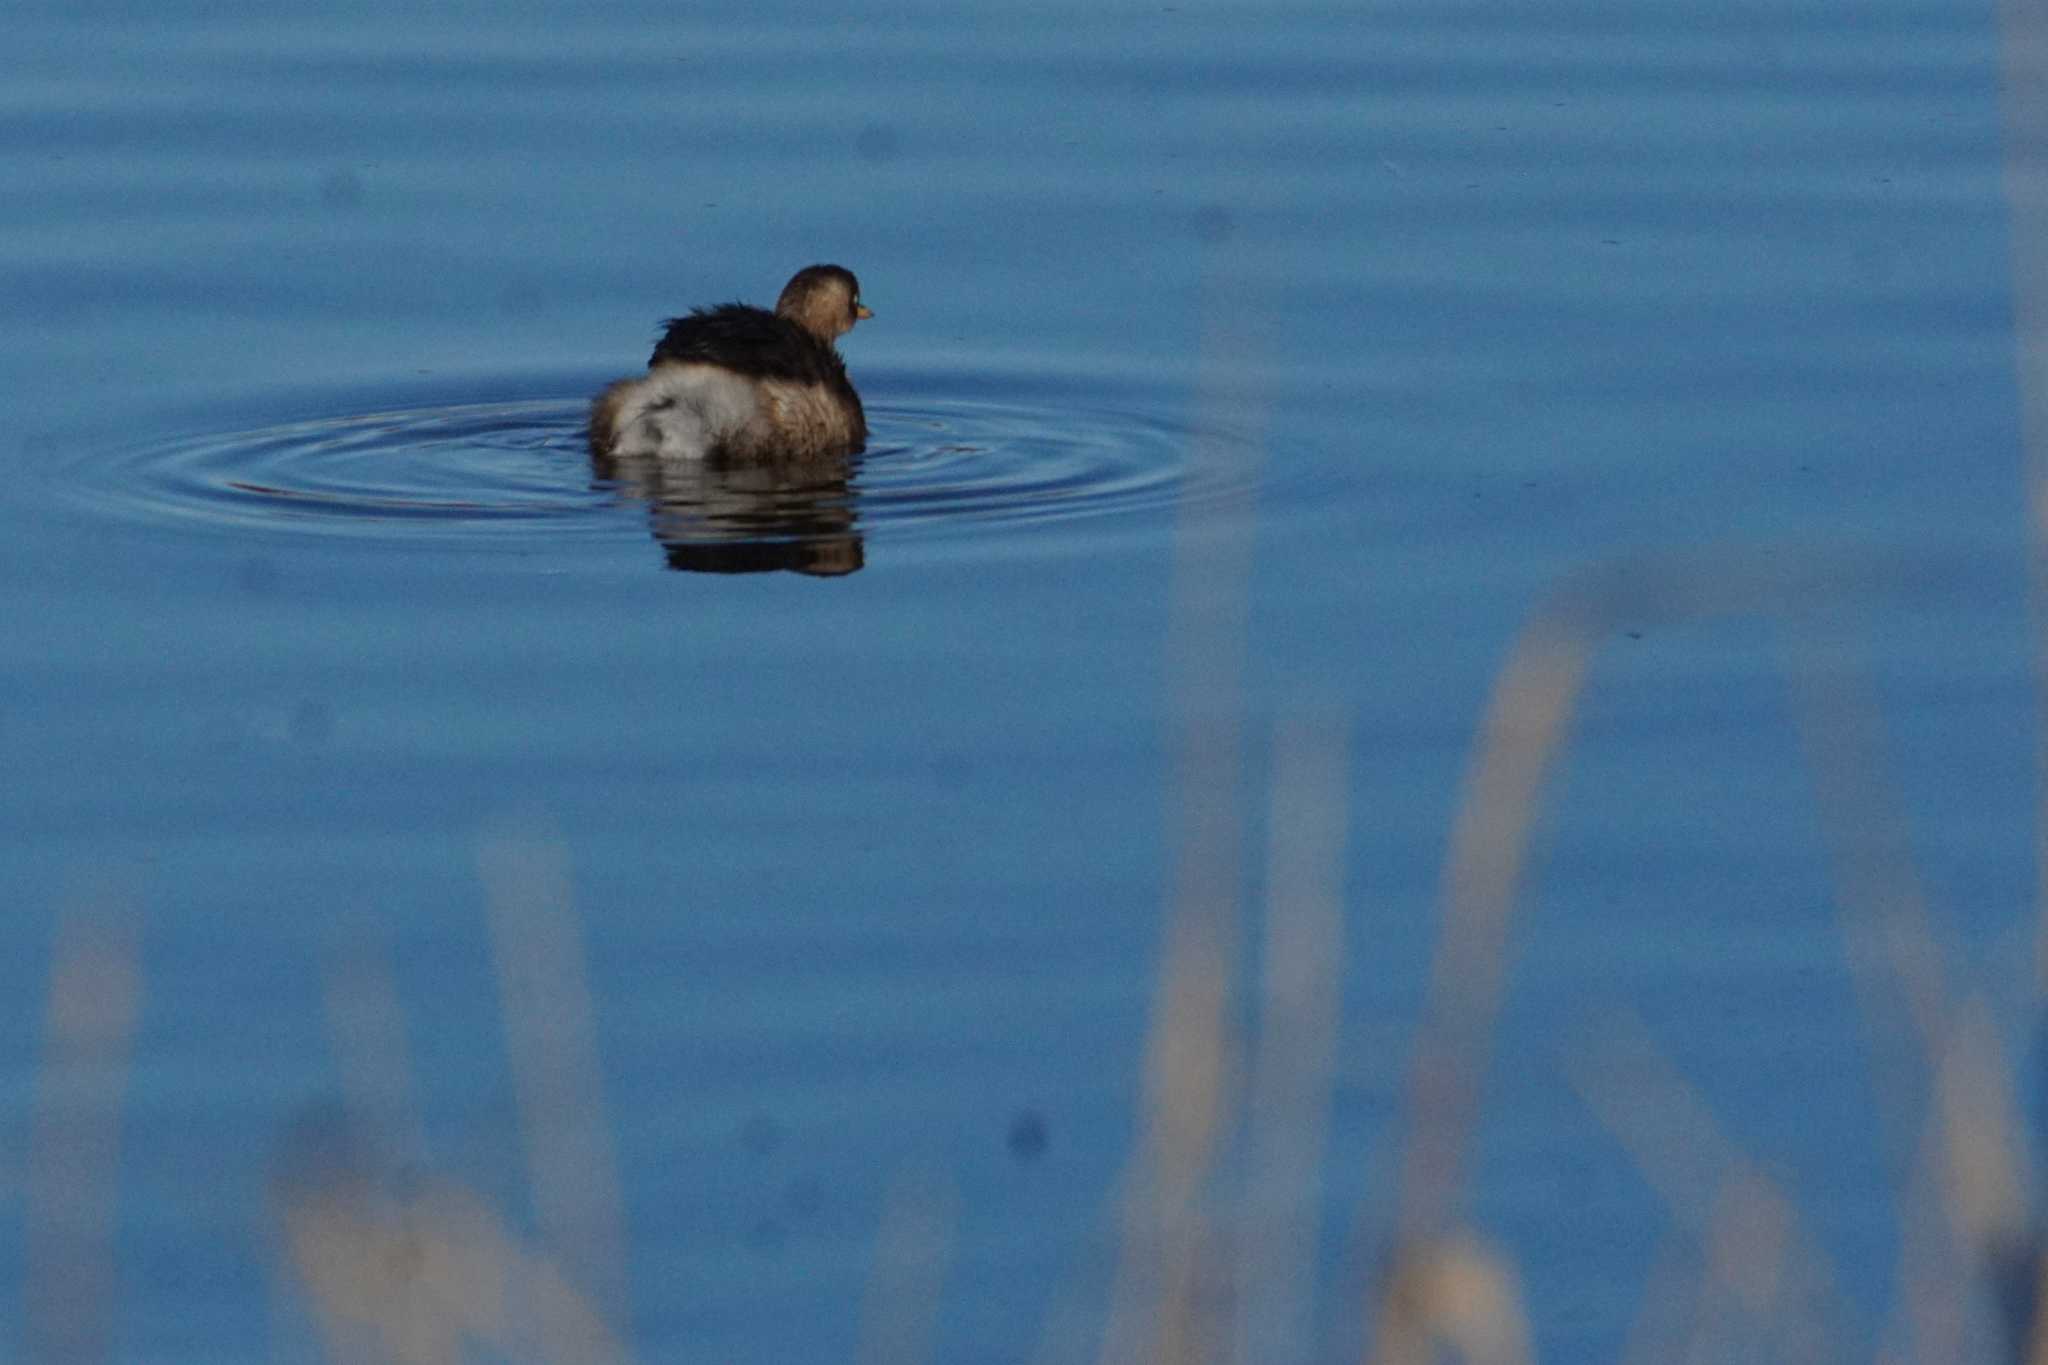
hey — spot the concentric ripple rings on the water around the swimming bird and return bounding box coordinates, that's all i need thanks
[44,383,1277,564]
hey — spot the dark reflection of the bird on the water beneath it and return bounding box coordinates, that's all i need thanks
[590,452,866,577]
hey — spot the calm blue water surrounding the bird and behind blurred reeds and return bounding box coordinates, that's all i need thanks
[0,0,2040,1361]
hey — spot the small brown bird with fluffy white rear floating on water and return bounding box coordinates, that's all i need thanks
[590,264,874,465]
